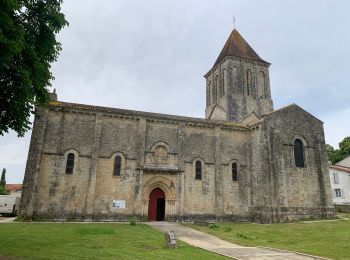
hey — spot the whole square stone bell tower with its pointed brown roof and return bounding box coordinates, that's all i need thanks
[204,29,273,122]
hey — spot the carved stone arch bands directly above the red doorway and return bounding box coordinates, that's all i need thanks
[142,176,176,200]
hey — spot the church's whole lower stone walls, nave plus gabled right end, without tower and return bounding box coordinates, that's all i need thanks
[21,102,333,222]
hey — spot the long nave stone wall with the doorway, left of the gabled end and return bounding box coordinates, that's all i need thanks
[23,105,253,219]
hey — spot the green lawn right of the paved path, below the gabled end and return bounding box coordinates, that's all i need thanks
[186,220,350,259]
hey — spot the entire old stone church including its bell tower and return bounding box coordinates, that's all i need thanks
[20,29,334,223]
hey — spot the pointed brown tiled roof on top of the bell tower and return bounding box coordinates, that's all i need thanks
[213,29,269,67]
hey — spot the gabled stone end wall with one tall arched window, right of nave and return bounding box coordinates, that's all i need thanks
[253,105,334,221]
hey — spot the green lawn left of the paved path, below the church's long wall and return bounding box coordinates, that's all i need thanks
[0,223,224,259]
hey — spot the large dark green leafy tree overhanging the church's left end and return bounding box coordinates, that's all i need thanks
[0,0,68,136]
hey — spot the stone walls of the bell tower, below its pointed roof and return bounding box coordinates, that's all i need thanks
[205,57,273,122]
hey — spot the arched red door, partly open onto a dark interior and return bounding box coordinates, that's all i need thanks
[148,188,165,221]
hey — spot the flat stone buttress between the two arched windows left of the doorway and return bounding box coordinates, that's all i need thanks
[85,113,103,218]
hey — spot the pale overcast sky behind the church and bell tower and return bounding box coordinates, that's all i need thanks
[0,0,350,183]
